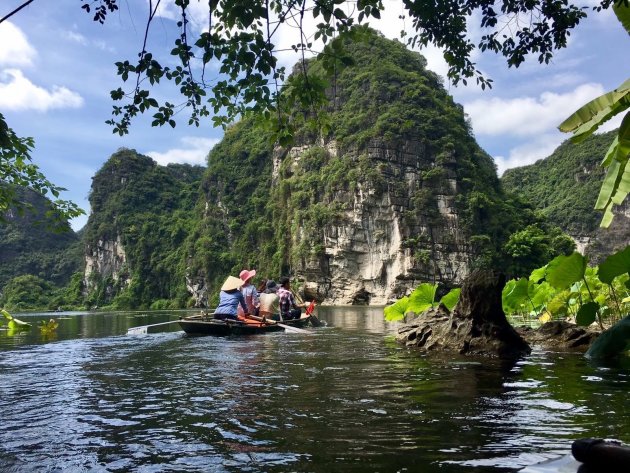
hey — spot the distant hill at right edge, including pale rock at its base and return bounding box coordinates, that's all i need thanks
[501,131,630,261]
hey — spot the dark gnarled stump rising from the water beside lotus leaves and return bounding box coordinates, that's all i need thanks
[397,271,531,358]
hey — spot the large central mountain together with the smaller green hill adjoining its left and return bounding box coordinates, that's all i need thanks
[3,30,584,308]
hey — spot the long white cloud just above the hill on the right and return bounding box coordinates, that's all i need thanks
[464,83,605,137]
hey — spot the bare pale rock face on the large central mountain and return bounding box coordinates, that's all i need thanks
[286,138,470,305]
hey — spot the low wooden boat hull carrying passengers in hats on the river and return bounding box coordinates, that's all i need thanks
[178,314,311,337]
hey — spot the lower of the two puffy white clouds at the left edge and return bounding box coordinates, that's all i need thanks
[0,69,83,112]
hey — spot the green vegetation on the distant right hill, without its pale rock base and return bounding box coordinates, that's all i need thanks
[501,132,616,235]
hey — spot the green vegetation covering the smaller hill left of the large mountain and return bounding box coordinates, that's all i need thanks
[85,149,204,308]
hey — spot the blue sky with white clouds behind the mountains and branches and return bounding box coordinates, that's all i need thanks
[0,0,630,230]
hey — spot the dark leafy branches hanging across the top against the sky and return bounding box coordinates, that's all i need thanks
[58,0,612,137]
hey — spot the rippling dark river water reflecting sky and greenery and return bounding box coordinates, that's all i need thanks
[0,307,630,473]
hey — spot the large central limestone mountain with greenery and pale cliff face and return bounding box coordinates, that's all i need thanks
[196,33,548,305]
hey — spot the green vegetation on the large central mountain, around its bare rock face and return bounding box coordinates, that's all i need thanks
[194,30,573,296]
